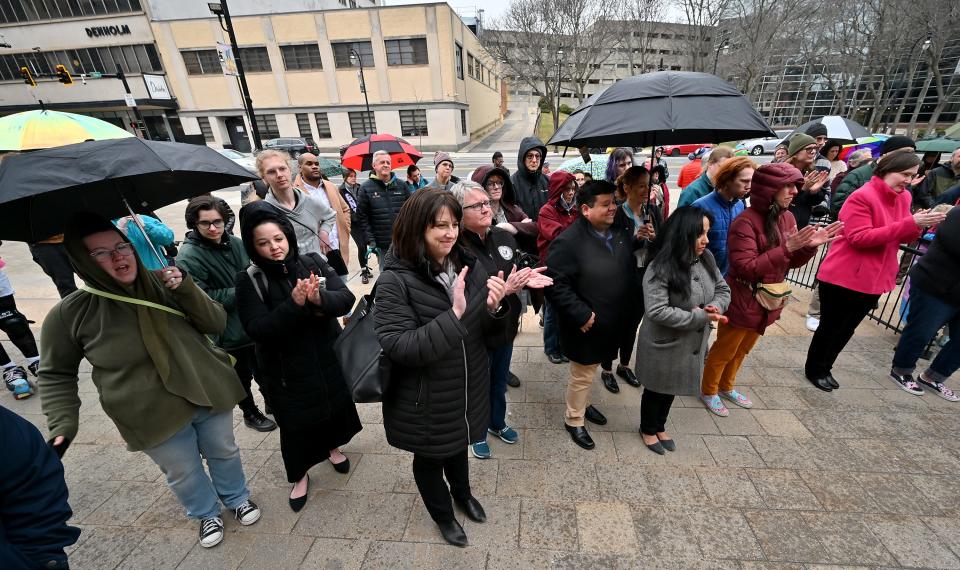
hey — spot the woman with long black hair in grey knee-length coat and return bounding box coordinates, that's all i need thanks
[636,206,730,455]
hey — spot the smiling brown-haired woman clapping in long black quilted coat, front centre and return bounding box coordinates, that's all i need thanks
[374,189,507,547]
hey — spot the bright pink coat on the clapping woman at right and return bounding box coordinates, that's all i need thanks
[817,176,922,295]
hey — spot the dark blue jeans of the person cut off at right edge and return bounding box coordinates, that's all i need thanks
[893,287,960,382]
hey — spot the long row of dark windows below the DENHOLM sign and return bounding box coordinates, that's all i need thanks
[0,43,163,81]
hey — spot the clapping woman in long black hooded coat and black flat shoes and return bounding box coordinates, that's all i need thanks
[236,202,363,511]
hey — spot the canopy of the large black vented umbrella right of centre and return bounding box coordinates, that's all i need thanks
[547,71,775,147]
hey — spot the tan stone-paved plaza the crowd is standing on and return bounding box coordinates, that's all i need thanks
[2,197,960,570]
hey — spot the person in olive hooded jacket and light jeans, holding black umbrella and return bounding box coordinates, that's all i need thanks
[39,213,260,548]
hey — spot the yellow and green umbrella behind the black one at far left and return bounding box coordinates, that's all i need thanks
[0,109,134,152]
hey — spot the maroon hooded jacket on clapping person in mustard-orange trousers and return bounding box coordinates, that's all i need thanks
[724,171,817,334]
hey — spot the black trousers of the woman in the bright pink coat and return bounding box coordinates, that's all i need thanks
[804,281,880,380]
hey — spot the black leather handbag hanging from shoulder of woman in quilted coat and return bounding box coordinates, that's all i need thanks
[333,279,406,404]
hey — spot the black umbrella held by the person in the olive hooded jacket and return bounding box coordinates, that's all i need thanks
[0,138,256,242]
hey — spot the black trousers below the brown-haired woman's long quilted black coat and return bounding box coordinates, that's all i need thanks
[413,448,470,522]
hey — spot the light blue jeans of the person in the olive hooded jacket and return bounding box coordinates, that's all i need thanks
[143,408,250,519]
